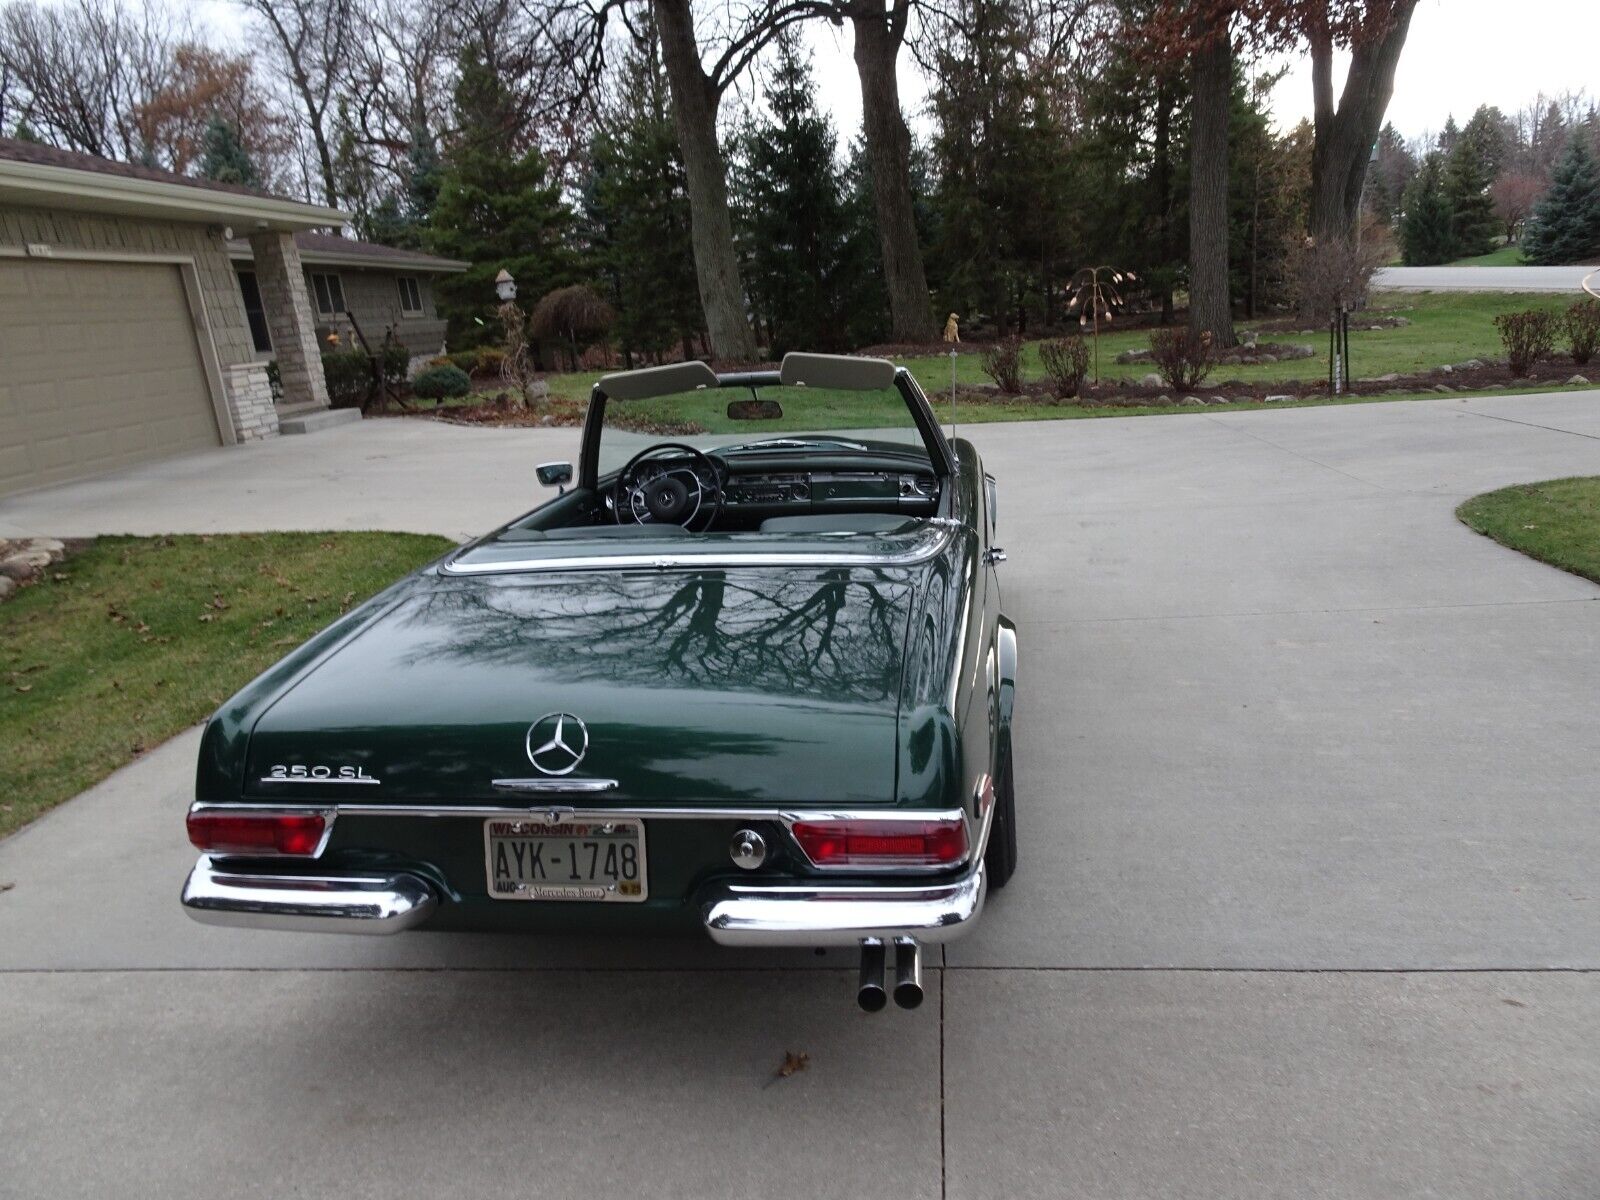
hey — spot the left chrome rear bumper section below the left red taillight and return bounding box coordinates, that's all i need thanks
[184,854,438,933]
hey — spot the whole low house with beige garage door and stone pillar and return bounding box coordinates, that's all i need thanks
[0,139,461,496]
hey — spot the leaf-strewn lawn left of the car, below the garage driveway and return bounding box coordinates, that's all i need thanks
[0,533,450,837]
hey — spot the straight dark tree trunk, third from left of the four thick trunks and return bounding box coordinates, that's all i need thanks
[1189,13,1234,350]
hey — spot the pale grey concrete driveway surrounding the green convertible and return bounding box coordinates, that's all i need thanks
[0,392,1600,1200]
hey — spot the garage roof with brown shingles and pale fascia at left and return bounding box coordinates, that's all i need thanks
[0,138,350,230]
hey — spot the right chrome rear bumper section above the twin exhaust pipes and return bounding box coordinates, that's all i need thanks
[704,861,986,946]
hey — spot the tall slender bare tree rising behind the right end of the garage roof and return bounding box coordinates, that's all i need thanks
[240,0,355,206]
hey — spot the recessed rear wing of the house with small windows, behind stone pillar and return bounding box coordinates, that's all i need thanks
[227,230,467,371]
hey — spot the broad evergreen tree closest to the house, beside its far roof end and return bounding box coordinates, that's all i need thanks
[427,50,578,346]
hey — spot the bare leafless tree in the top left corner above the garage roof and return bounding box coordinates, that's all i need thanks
[0,0,192,162]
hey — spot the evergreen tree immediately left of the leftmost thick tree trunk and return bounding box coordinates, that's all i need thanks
[582,24,706,362]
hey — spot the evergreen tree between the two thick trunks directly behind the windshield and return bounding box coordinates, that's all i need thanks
[730,34,870,357]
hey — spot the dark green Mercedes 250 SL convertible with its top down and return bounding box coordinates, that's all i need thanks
[182,354,1018,1010]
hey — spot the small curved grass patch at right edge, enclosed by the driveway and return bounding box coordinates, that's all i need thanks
[1456,475,1600,584]
